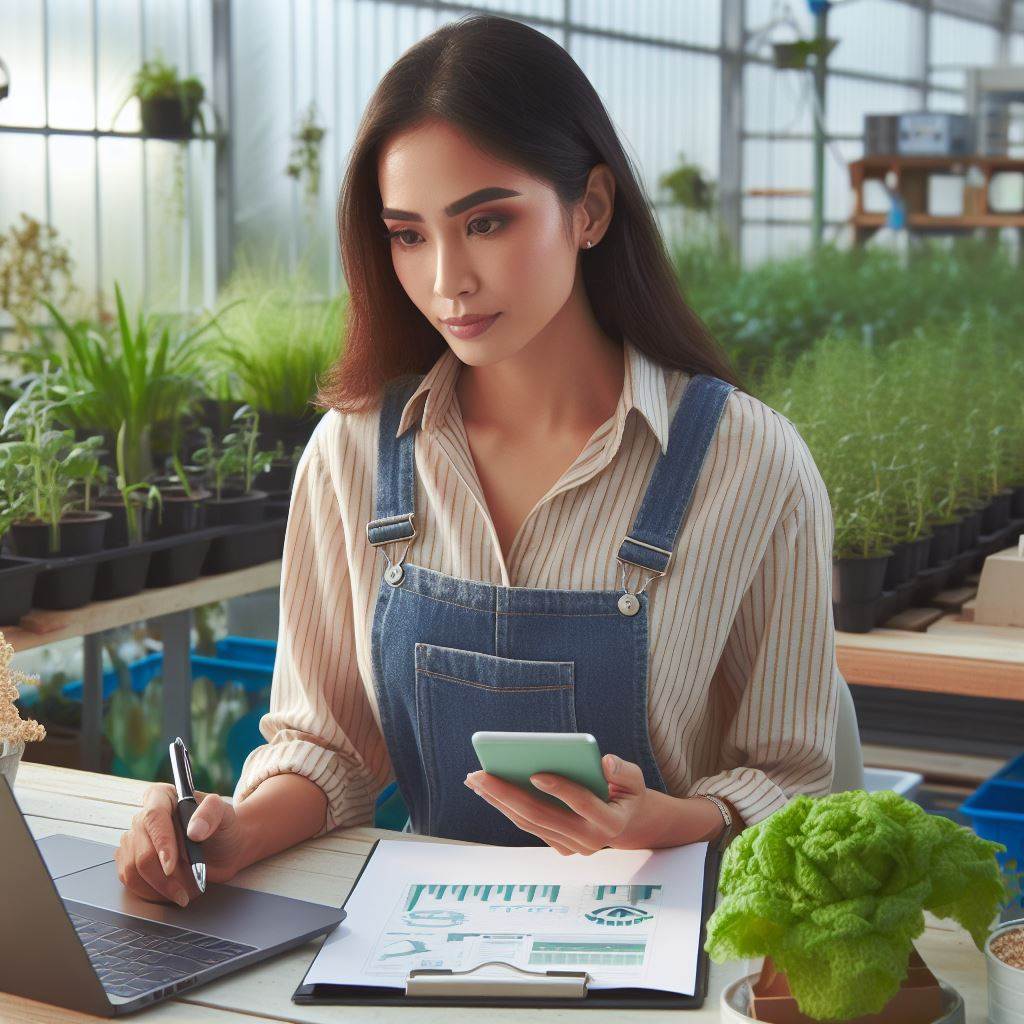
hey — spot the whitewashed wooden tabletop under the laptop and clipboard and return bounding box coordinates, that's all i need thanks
[0,763,987,1024]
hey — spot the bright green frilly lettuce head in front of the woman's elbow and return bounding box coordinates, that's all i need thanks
[705,790,1007,1020]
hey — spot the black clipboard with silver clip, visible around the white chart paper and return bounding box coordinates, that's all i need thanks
[292,834,731,1010]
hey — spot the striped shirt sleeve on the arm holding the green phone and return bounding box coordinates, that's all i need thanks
[686,442,840,826]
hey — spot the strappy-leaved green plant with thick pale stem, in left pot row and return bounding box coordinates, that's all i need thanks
[37,284,211,483]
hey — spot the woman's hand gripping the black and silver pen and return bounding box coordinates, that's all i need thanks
[114,782,245,906]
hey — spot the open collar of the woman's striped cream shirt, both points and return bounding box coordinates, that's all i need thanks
[395,338,669,453]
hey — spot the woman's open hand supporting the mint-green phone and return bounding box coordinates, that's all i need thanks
[466,754,718,854]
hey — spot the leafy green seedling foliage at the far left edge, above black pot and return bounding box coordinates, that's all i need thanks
[0,367,102,552]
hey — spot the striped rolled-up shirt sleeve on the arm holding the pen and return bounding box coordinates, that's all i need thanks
[233,428,393,836]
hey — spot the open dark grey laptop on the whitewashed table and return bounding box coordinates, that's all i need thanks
[0,776,345,1017]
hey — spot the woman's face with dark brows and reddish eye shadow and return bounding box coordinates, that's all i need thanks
[377,121,597,366]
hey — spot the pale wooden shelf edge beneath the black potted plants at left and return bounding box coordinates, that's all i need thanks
[3,559,281,651]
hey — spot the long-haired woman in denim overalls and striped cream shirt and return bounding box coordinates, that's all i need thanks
[118,16,838,904]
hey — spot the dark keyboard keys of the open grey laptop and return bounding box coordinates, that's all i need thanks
[69,913,256,996]
